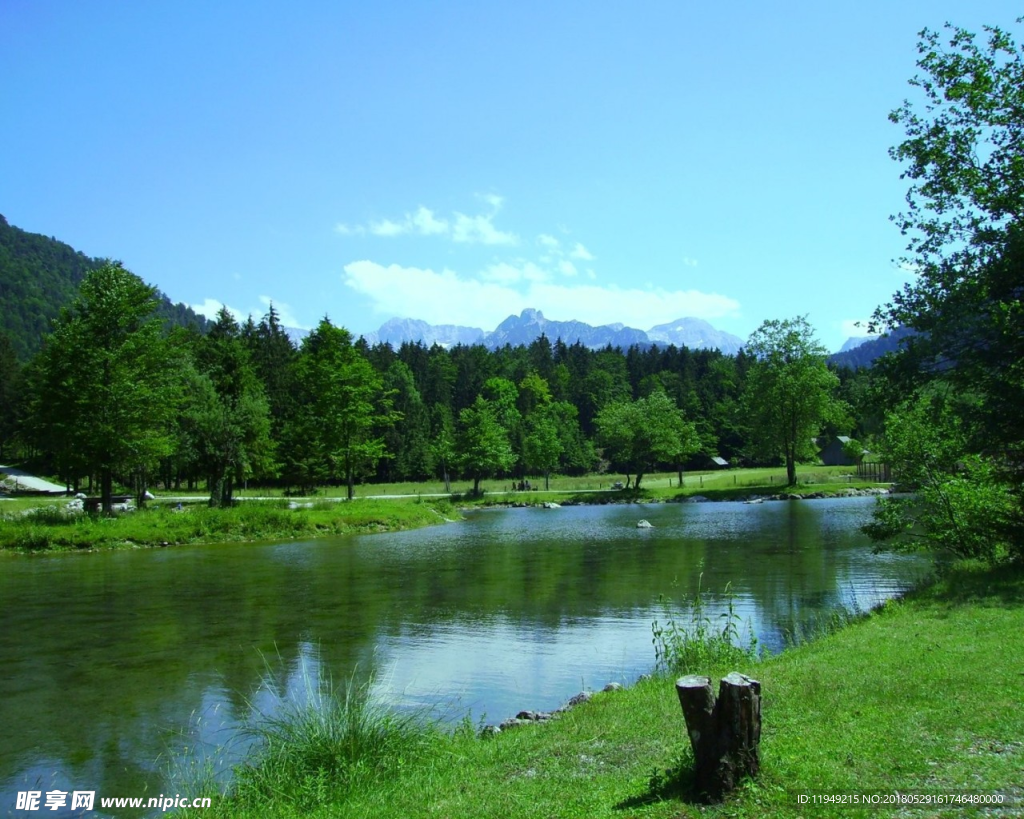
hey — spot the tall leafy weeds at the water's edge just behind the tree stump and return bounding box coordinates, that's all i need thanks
[651,571,758,675]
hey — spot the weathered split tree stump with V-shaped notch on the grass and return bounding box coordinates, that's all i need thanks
[676,672,761,802]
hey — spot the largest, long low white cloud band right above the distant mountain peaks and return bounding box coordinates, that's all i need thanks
[342,260,739,330]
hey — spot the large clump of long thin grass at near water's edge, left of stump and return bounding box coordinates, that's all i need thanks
[229,680,440,812]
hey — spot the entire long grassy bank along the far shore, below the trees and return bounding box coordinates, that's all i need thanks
[0,467,873,552]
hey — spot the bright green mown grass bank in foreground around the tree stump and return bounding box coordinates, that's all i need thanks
[182,568,1024,819]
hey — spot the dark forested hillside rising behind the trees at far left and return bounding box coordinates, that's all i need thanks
[0,215,207,361]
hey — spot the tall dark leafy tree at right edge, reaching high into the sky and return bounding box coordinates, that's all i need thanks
[874,18,1024,556]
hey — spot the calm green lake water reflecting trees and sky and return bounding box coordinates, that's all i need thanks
[0,499,928,816]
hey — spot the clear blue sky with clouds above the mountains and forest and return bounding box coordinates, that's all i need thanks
[0,0,1021,349]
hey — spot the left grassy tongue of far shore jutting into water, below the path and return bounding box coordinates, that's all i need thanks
[0,499,458,552]
